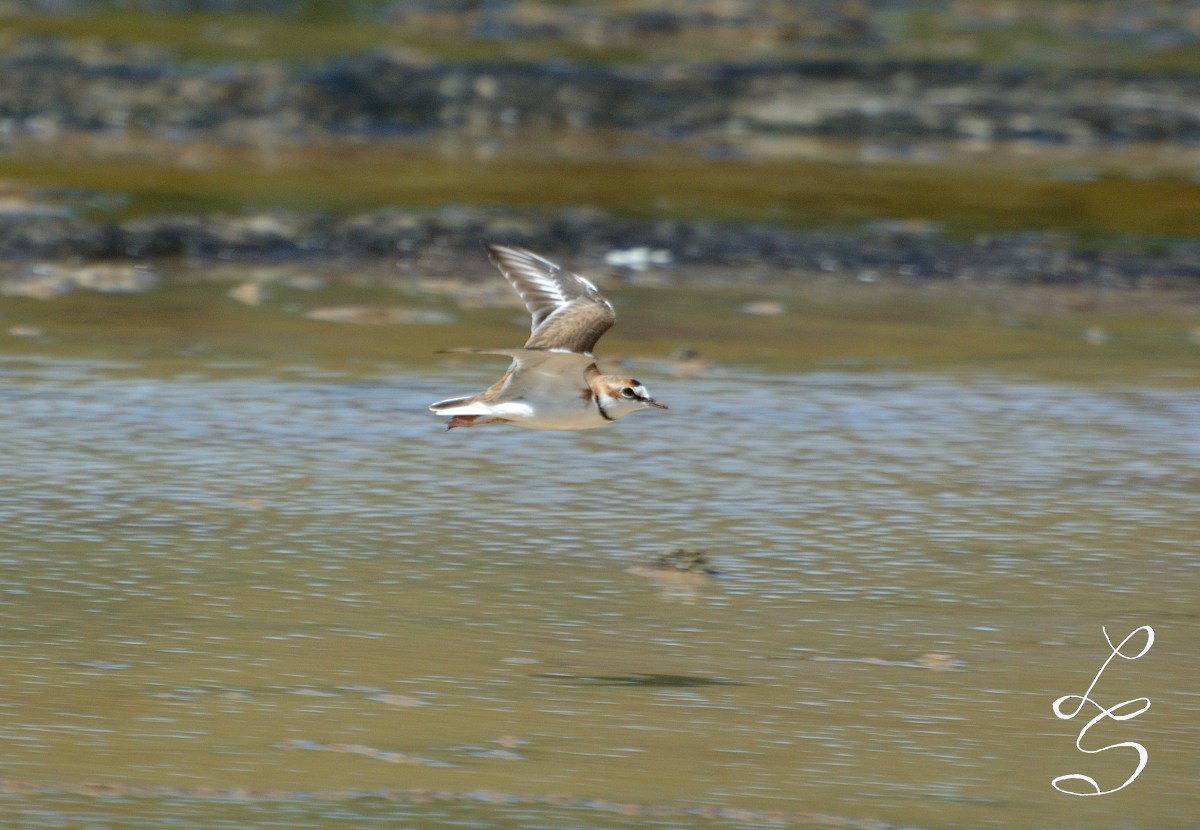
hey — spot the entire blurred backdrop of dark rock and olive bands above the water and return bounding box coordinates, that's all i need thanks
[0,0,1200,369]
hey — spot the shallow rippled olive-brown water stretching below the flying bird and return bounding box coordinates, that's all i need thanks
[0,275,1200,829]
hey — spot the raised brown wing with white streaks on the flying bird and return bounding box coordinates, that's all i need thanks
[484,242,617,353]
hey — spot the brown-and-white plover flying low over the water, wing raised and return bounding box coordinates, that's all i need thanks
[430,242,667,429]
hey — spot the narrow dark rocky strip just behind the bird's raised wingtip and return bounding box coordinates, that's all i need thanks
[7,203,1200,288]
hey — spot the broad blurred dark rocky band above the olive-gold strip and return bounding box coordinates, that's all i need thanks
[7,38,1200,145]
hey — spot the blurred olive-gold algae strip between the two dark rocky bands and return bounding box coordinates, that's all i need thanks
[0,145,1200,237]
